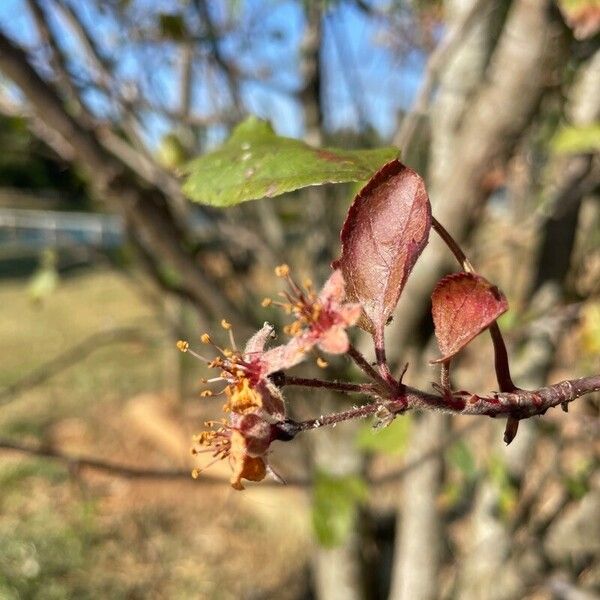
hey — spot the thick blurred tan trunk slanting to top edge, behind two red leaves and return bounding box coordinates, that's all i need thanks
[388,0,566,356]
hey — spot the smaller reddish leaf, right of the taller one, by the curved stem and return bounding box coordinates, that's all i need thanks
[431,273,508,363]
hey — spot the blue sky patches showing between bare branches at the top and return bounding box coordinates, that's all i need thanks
[0,0,424,144]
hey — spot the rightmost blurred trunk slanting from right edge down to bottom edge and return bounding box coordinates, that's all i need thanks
[459,43,600,600]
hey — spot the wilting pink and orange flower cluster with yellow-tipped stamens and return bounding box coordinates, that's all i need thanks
[178,265,361,490]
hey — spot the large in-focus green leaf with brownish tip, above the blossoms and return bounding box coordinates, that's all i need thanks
[183,117,398,207]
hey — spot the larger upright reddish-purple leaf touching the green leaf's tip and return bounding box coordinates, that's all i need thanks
[334,160,431,337]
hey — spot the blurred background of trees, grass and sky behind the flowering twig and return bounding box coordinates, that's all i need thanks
[0,0,600,600]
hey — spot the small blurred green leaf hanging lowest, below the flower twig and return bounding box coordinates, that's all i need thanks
[312,471,368,548]
